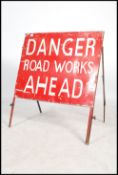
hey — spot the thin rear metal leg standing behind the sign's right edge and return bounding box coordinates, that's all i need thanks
[102,48,106,122]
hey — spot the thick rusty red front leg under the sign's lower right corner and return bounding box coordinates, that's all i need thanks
[85,107,93,144]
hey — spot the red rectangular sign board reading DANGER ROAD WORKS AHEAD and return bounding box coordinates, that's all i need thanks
[15,32,104,106]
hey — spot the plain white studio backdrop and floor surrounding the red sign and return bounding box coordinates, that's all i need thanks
[2,1,116,174]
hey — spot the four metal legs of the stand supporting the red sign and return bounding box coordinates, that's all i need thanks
[9,47,106,144]
